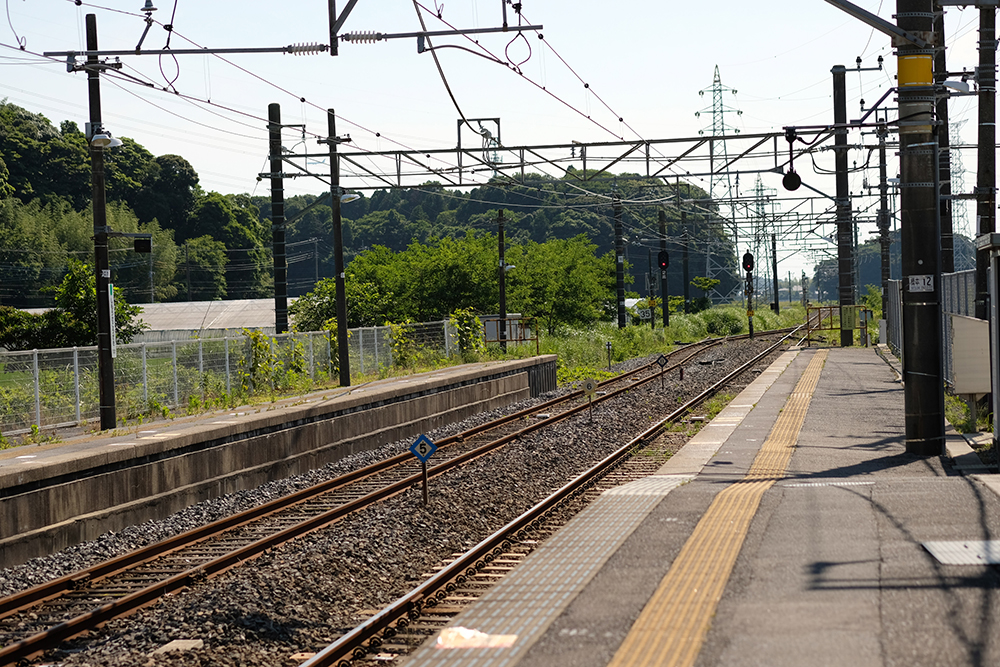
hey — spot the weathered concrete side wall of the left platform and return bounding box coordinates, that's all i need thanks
[0,356,556,567]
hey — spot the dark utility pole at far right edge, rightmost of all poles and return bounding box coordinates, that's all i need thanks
[976,4,997,320]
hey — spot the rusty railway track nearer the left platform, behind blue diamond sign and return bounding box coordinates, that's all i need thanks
[0,334,796,664]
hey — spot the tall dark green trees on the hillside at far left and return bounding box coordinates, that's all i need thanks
[0,102,271,307]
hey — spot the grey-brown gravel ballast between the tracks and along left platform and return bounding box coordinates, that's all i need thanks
[0,340,769,667]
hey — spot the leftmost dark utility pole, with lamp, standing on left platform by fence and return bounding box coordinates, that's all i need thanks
[86,14,118,431]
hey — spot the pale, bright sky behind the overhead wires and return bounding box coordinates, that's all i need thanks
[0,0,978,274]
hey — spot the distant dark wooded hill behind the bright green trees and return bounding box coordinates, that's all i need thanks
[253,174,736,296]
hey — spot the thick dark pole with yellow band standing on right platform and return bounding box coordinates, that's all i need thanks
[895,0,947,456]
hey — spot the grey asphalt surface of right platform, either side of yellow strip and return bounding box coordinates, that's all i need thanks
[414,348,1000,667]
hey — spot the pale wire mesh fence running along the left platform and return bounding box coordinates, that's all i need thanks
[0,321,457,435]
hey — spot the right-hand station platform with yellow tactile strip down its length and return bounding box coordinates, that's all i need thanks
[401,348,1000,667]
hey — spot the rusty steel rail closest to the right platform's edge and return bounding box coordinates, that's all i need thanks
[300,328,798,667]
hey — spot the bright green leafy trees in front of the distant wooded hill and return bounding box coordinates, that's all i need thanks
[292,232,616,332]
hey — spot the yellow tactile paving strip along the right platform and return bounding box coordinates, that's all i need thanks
[608,350,827,667]
